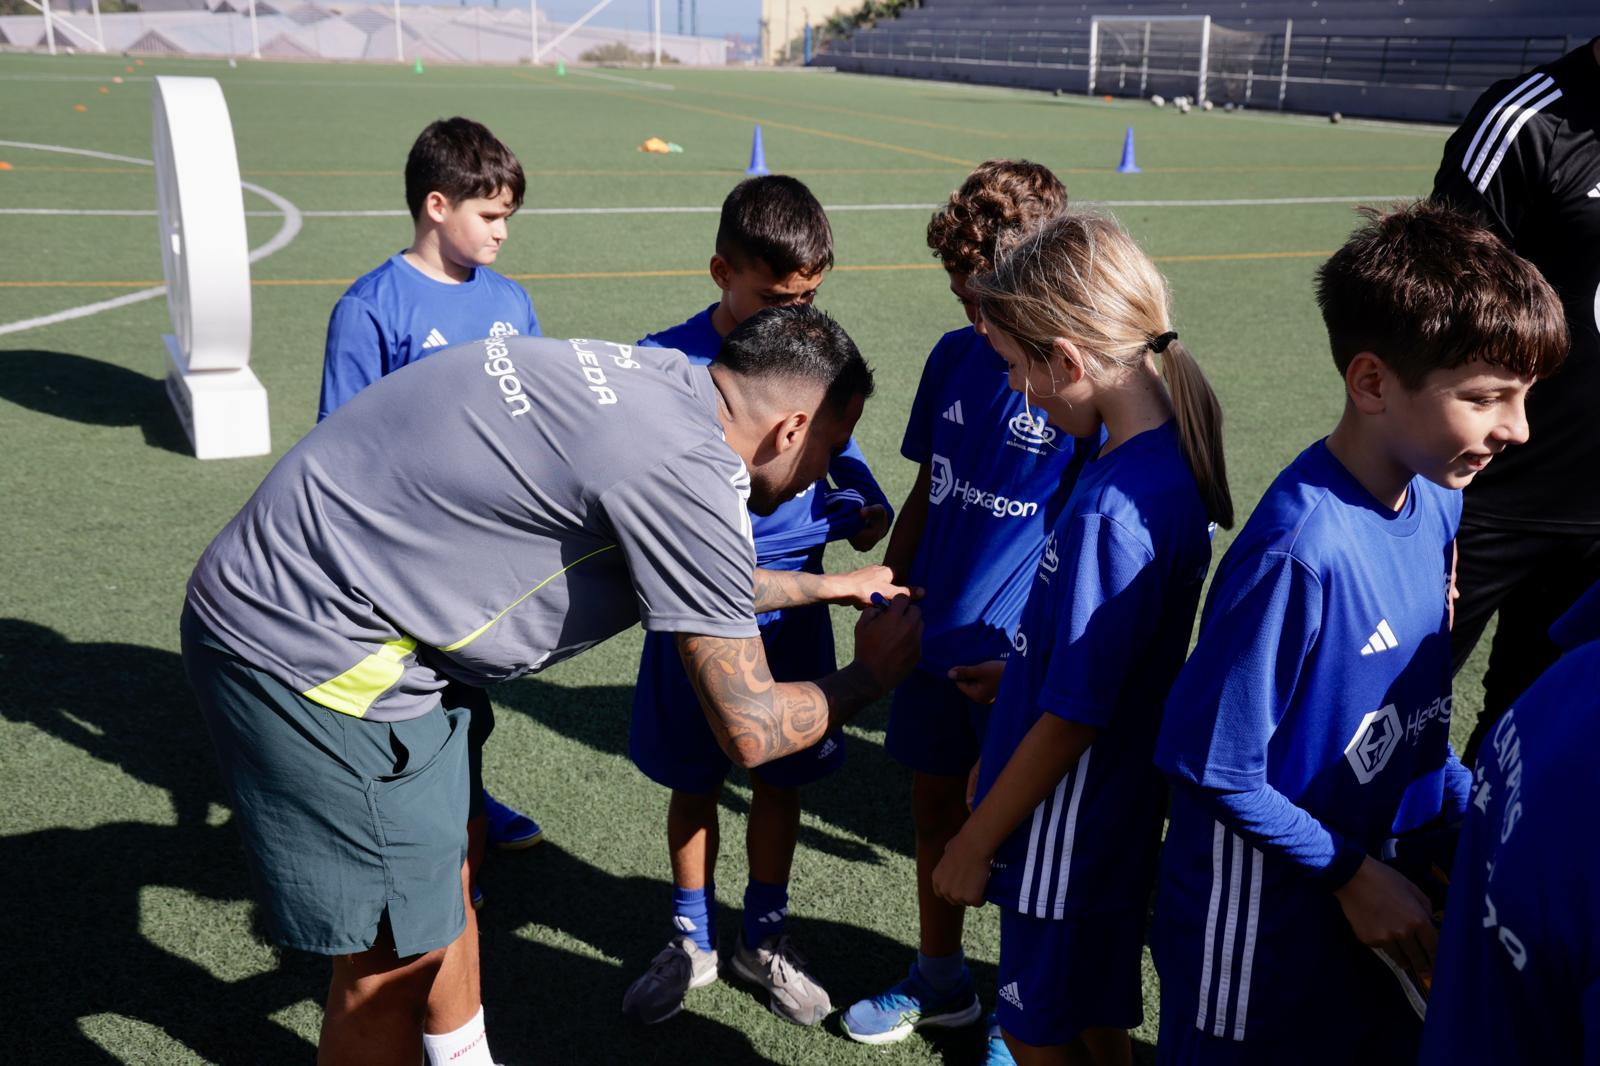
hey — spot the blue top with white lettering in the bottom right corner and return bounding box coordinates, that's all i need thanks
[1421,586,1600,1066]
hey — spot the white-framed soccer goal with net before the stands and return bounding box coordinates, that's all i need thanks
[1088,14,1275,104]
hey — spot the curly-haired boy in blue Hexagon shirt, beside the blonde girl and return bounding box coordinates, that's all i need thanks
[843,160,1083,1063]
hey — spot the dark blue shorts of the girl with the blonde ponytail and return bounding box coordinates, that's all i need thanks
[995,906,1144,1047]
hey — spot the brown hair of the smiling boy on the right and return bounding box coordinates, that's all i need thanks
[1317,200,1568,389]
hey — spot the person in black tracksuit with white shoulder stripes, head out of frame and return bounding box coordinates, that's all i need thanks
[1434,37,1600,763]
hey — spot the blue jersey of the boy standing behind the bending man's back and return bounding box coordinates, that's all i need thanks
[317,253,539,421]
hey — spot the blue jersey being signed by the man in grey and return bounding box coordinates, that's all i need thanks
[640,304,893,573]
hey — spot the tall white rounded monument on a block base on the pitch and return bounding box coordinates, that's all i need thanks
[150,75,272,459]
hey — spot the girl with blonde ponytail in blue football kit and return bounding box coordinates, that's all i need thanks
[933,213,1234,1066]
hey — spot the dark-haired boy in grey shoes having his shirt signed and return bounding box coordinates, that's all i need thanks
[622,174,890,1024]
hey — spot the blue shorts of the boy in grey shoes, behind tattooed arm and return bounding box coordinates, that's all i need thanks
[627,603,845,794]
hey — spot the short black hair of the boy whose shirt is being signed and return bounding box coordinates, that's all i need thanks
[717,174,834,277]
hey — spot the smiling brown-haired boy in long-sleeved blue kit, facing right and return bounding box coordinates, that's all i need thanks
[1152,202,1566,1066]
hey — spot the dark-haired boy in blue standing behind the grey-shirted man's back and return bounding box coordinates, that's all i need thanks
[317,117,544,877]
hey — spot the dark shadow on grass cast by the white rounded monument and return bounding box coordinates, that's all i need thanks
[0,349,189,455]
